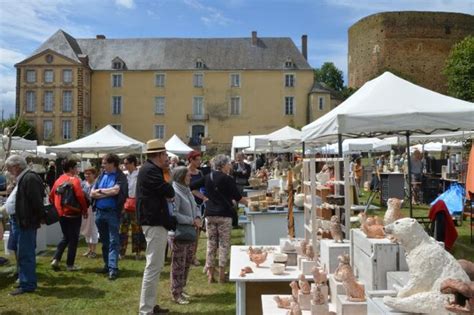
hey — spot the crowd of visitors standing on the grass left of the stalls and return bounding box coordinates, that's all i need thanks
[0,139,260,314]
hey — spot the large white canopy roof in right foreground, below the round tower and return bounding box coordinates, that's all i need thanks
[302,72,474,143]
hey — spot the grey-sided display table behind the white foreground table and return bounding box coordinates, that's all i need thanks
[239,209,304,245]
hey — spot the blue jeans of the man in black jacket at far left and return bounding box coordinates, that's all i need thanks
[17,227,37,292]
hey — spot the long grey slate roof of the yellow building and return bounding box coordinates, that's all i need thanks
[30,30,312,70]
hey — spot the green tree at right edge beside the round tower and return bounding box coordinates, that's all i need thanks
[443,35,474,102]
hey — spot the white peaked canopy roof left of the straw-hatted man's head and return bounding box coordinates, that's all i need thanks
[46,125,144,153]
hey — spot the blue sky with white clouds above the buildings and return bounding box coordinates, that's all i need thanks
[0,0,474,118]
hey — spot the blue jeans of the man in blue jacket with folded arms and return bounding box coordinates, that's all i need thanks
[95,209,120,274]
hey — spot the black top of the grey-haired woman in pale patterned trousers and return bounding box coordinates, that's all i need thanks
[190,171,242,217]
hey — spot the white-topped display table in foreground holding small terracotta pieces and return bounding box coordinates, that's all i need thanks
[229,246,313,315]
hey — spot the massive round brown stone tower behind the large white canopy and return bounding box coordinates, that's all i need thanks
[348,11,474,93]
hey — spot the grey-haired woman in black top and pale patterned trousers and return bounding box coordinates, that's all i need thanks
[190,154,247,283]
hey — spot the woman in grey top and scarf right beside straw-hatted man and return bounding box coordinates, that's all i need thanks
[170,166,201,304]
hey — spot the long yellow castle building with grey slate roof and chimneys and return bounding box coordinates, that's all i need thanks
[15,30,334,146]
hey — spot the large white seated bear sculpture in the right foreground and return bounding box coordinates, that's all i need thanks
[384,218,470,315]
